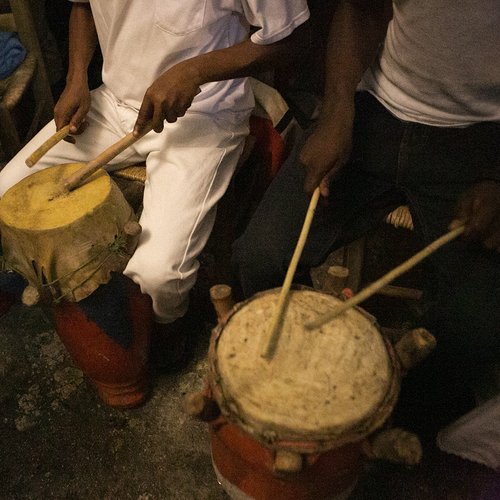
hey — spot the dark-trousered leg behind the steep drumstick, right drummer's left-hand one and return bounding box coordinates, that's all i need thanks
[233,91,408,297]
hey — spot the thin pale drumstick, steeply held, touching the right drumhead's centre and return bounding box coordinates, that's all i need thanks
[262,187,320,361]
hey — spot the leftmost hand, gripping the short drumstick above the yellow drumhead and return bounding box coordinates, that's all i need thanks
[54,84,90,135]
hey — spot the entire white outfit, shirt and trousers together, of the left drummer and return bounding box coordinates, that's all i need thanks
[0,0,309,323]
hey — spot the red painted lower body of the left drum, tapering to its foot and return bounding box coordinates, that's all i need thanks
[52,281,153,408]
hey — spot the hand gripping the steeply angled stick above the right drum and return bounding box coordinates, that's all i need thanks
[299,99,354,197]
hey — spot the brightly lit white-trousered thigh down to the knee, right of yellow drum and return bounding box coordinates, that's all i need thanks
[126,113,248,281]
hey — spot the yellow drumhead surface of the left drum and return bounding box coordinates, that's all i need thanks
[0,163,111,230]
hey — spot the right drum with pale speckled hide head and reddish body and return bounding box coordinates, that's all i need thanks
[208,288,400,500]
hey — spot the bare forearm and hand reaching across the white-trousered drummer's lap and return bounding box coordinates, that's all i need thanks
[134,23,309,136]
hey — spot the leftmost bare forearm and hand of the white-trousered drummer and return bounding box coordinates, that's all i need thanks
[54,3,98,134]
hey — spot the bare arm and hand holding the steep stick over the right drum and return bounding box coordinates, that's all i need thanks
[300,0,392,196]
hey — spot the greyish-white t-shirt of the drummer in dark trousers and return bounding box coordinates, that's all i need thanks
[360,0,500,127]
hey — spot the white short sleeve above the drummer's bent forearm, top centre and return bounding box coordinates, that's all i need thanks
[242,0,310,45]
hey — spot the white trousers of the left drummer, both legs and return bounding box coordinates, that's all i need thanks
[0,87,248,323]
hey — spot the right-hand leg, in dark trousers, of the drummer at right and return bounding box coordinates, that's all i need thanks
[392,119,500,437]
